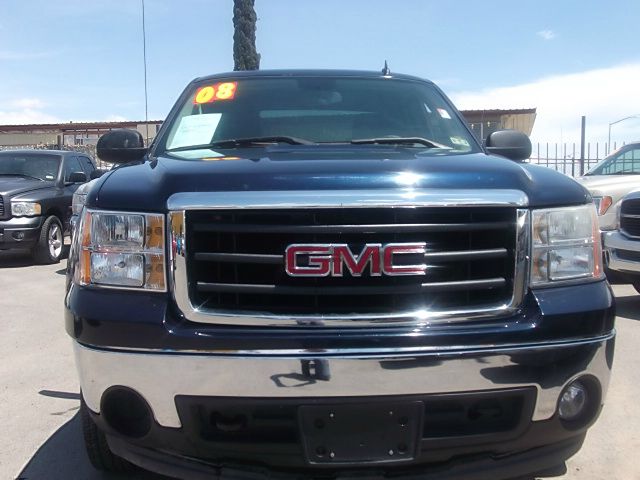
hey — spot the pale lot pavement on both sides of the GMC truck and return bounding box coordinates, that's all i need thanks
[0,252,640,480]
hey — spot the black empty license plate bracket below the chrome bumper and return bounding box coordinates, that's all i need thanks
[298,401,424,464]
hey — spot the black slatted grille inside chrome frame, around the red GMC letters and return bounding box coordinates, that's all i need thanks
[185,206,517,318]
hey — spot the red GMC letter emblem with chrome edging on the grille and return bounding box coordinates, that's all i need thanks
[285,242,427,277]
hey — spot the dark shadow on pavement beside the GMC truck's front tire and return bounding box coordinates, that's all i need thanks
[16,413,171,480]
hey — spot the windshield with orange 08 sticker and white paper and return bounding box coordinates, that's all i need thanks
[159,77,479,157]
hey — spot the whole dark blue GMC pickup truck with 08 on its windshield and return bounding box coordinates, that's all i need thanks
[65,71,615,480]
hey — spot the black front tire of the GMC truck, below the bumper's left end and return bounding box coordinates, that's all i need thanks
[80,394,136,473]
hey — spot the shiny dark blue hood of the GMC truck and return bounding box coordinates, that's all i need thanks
[87,145,590,211]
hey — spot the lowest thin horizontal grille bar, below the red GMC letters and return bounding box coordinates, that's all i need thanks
[197,278,506,295]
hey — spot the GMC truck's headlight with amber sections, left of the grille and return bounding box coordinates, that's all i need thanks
[75,210,166,292]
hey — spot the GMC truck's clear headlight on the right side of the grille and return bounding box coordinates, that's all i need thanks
[531,205,603,287]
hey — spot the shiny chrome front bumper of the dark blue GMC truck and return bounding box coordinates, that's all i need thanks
[74,332,615,428]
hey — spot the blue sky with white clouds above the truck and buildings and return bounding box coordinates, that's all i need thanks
[0,0,640,141]
